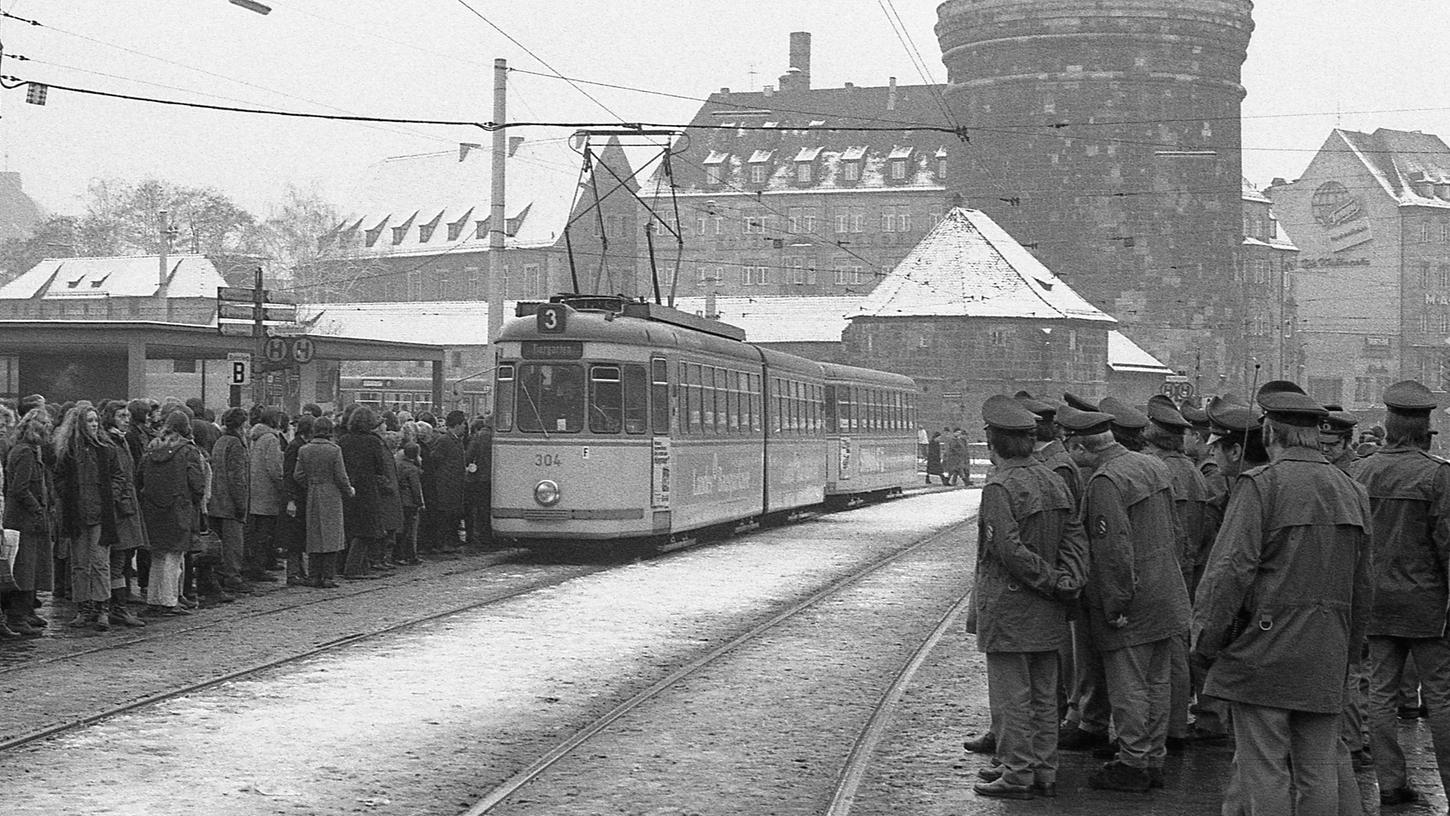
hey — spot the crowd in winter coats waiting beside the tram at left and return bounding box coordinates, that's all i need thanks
[0,394,493,639]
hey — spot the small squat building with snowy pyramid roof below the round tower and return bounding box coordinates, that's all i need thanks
[842,209,1117,428]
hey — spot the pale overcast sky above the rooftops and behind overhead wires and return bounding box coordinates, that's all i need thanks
[0,0,1450,216]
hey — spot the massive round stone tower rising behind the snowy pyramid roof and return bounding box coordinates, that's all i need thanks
[937,0,1254,393]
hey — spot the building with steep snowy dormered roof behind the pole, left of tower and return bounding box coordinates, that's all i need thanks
[307,136,645,307]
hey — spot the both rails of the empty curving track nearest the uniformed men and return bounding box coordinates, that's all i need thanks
[460,520,970,816]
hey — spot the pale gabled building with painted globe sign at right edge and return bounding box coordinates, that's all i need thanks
[1266,129,1450,416]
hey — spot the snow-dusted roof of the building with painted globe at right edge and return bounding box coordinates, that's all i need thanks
[1334,128,1450,209]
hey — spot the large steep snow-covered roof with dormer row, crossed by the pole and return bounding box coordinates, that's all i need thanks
[326,138,632,258]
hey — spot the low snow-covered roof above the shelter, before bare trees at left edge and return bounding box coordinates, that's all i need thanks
[0,255,226,300]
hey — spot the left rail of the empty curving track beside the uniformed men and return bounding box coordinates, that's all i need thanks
[460,519,972,816]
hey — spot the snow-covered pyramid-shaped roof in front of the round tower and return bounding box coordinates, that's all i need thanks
[850,207,1117,323]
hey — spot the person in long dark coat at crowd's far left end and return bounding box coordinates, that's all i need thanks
[0,407,55,636]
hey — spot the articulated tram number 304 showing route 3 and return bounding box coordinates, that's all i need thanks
[492,296,916,544]
